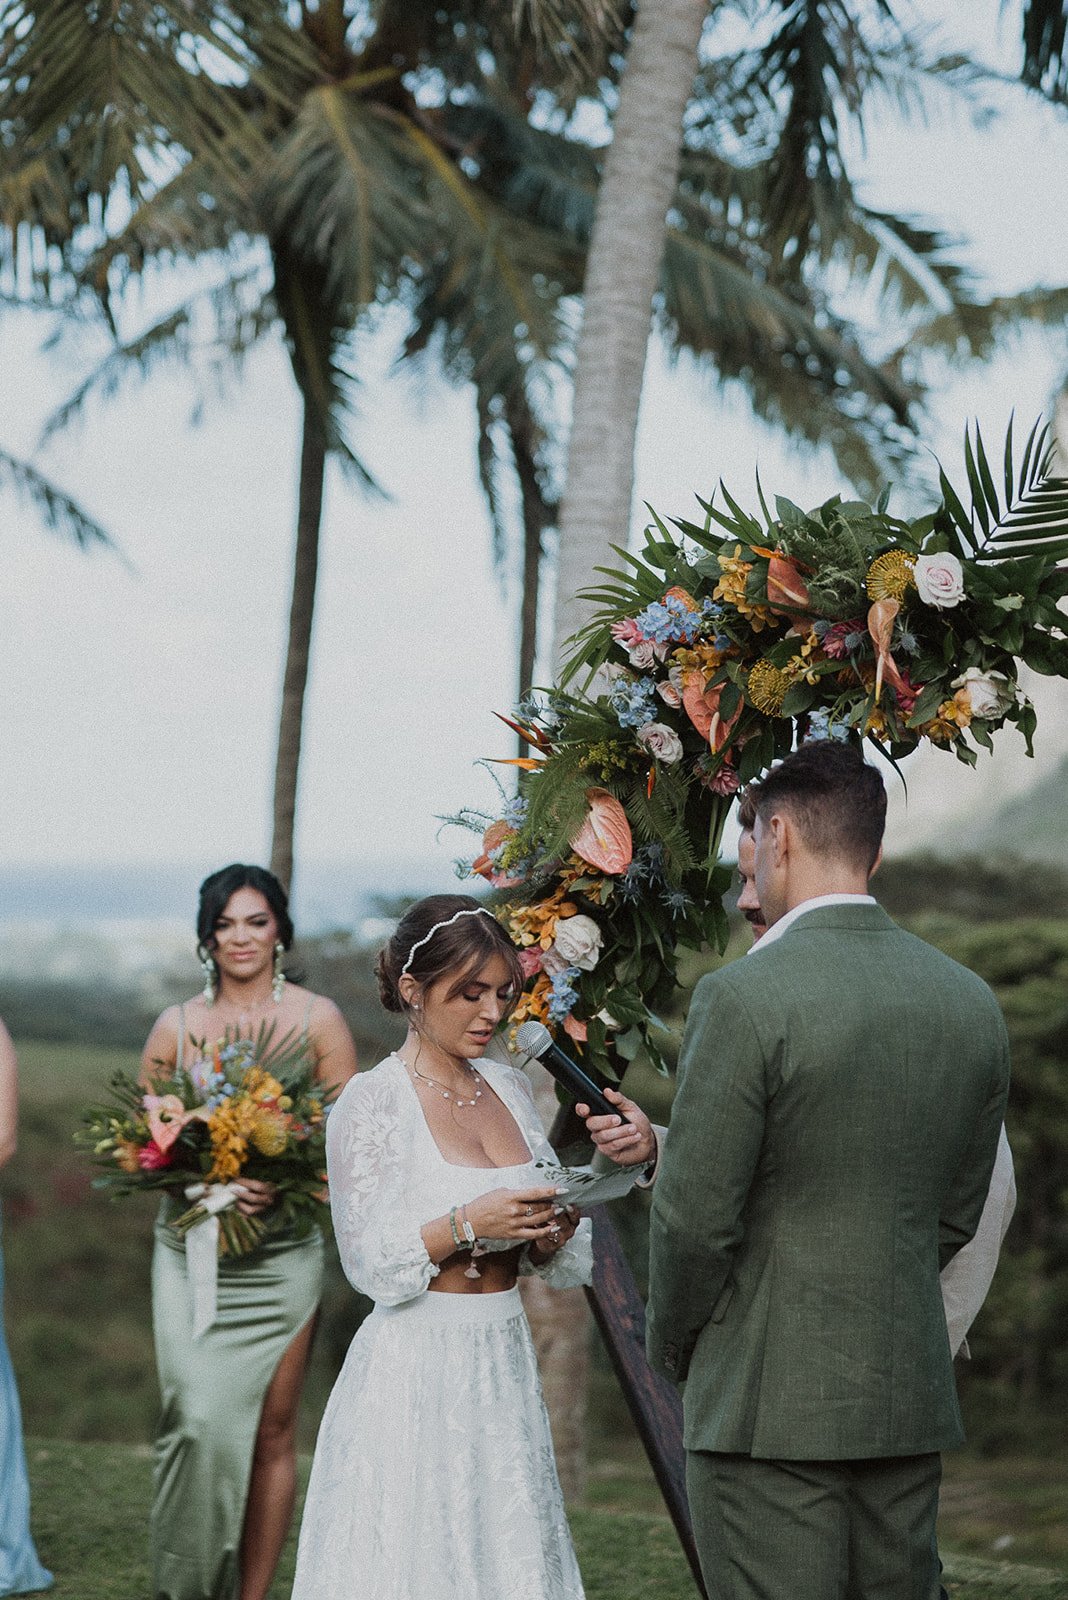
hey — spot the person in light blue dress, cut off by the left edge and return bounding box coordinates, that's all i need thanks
[0,1022,51,1595]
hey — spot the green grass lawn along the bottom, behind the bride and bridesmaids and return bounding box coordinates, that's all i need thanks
[20,1438,1068,1600]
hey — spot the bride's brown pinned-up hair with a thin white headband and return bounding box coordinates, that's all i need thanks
[374,894,523,1013]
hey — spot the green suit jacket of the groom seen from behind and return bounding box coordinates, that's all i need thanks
[648,902,1009,1461]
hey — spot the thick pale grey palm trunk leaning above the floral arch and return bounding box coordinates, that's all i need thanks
[553,0,708,669]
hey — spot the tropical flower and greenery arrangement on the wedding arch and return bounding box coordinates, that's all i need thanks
[462,424,1068,1077]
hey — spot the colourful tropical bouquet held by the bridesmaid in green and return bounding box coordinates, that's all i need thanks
[75,1024,329,1256]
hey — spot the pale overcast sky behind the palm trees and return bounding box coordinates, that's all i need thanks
[0,0,1068,917]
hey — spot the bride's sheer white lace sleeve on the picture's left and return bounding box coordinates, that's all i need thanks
[326,1072,440,1306]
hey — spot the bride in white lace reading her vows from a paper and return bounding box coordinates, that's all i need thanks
[293,894,592,1600]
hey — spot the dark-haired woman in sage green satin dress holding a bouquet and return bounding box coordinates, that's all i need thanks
[142,864,357,1600]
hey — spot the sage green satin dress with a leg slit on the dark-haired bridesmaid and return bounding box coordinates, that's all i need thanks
[152,1013,323,1600]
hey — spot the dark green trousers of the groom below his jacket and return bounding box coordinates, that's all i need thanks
[686,1450,943,1600]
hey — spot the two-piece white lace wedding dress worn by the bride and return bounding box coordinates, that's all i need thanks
[293,1056,593,1600]
